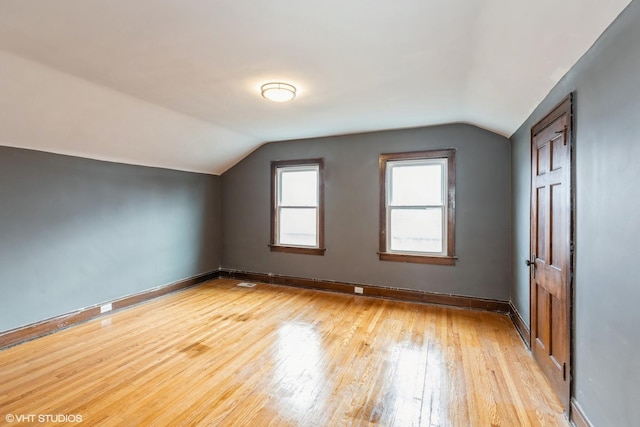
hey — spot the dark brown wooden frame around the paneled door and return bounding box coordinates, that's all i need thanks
[529,92,576,416]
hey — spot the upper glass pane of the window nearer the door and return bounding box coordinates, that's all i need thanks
[390,164,444,206]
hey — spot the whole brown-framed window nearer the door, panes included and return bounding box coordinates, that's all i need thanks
[379,149,456,265]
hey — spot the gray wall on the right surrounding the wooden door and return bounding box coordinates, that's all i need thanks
[512,1,640,426]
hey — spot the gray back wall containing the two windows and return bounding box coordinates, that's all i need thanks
[222,124,511,300]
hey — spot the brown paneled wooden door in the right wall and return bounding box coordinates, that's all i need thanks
[528,96,572,412]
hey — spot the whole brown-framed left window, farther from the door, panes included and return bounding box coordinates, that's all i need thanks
[270,159,325,255]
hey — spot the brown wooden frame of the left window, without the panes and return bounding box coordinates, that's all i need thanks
[269,158,326,255]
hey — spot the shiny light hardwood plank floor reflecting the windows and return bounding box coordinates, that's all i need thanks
[0,279,568,426]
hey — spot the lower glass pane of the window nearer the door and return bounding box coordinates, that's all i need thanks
[389,208,443,253]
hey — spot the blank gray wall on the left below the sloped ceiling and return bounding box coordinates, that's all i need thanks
[0,147,221,331]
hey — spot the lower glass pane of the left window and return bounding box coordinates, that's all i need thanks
[278,208,318,246]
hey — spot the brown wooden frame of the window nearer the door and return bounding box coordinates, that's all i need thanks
[378,148,457,265]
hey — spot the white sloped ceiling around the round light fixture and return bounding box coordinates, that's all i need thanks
[0,0,630,174]
